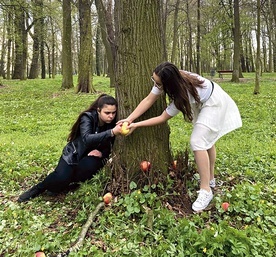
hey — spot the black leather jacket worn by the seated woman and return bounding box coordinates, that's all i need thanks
[62,110,116,165]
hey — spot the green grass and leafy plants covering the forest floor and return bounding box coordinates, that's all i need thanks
[0,74,276,257]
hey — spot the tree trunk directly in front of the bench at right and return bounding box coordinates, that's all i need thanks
[231,0,240,82]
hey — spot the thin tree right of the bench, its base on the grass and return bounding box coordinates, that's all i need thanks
[254,0,261,95]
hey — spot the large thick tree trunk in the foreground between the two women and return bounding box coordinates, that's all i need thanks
[114,0,171,190]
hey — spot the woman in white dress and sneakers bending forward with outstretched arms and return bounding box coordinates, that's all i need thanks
[119,62,242,212]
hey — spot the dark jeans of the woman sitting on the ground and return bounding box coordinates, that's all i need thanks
[37,156,104,193]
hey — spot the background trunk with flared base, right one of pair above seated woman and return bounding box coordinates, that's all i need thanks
[77,0,95,93]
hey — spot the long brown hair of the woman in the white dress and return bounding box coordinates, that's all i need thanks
[153,62,204,121]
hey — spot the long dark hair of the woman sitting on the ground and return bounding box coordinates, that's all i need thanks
[67,94,118,142]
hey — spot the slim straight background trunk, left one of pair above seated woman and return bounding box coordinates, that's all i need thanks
[61,0,74,89]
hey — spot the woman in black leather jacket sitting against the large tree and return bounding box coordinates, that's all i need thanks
[17,94,121,202]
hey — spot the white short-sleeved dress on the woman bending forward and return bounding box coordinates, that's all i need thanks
[151,73,242,151]
